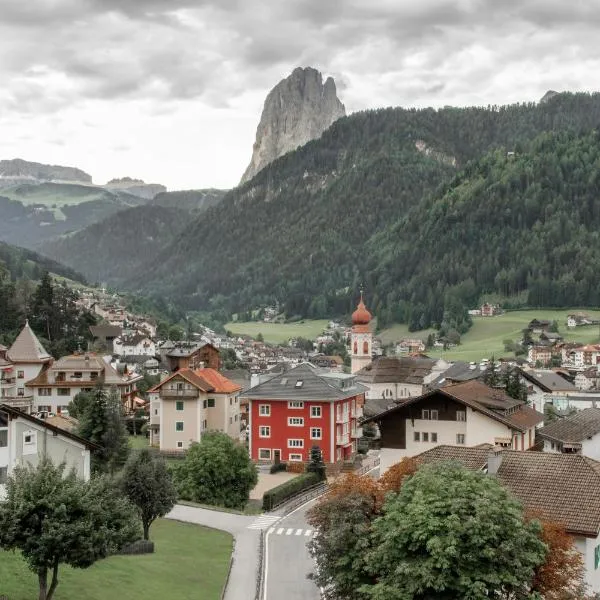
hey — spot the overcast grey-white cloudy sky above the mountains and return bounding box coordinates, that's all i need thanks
[0,0,600,189]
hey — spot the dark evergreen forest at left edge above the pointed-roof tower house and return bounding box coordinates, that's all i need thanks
[0,242,96,357]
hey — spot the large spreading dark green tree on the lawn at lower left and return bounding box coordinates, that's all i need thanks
[0,458,140,600]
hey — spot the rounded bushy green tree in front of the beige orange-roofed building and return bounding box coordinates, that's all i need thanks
[174,433,258,509]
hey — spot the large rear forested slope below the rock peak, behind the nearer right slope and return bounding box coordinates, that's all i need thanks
[131,94,600,321]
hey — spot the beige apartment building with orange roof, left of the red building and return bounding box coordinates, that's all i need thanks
[149,368,242,451]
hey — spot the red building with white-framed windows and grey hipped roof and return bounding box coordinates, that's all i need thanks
[240,363,366,463]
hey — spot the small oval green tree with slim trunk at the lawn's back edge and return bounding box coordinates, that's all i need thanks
[121,448,177,540]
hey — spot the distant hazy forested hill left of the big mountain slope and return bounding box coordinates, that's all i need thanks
[41,205,190,286]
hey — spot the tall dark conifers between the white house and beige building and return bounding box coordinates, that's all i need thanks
[78,384,129,473]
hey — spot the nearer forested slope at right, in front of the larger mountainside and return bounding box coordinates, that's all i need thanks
[368,131,600,329]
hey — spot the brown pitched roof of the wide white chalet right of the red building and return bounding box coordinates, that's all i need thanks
[365,380,544,432]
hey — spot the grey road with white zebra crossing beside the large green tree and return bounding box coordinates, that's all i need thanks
[263,500,321,600]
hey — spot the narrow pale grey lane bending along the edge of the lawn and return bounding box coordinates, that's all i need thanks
[167,504,258,600]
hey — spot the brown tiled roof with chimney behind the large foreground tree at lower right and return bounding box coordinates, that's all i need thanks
[415,446,600,537]
